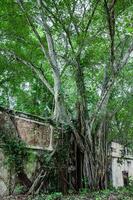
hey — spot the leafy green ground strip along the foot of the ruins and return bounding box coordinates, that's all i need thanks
[0,186,133,200]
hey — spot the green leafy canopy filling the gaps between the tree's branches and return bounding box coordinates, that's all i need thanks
[0,0,132,119]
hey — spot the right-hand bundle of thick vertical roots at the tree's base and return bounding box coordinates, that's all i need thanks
[83,120,107,189]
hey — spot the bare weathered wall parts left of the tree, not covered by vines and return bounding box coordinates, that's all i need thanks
[0,113,52,196]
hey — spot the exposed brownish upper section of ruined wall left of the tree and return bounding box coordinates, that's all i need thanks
[0,113,51,148]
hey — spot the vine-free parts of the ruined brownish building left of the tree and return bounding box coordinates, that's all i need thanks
[0,108,53,196]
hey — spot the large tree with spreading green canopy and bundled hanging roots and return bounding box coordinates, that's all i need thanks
[0,0,133,188]
